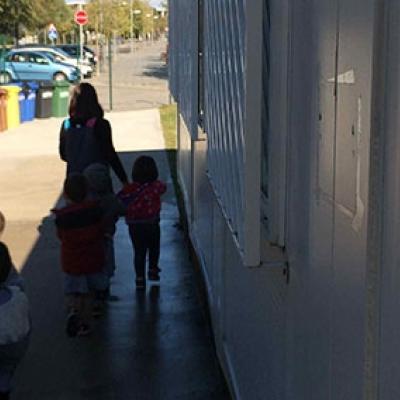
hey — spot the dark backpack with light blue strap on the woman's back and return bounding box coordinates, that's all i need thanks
[64,118,103,175]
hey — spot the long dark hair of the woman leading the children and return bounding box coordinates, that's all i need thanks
[69,82,104,121]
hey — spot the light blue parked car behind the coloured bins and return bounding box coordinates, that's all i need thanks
[0,50,79,83]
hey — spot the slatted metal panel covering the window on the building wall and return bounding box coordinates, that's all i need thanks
[204,0,245,247]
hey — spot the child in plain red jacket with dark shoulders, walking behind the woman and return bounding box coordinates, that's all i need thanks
[54,174,104,336]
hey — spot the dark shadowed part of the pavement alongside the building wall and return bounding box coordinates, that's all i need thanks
[12,151,230,400]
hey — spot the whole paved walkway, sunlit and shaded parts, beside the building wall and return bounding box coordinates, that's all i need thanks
[0,110,229,400]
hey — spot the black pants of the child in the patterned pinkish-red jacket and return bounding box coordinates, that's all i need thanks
[129,222,160,278]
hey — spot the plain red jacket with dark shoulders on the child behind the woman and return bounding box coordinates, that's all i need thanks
[54,201,104,275]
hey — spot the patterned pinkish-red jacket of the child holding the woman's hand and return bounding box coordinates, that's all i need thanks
[118,181,167,224]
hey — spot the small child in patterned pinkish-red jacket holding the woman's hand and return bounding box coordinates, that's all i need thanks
[118,156,167,289]
